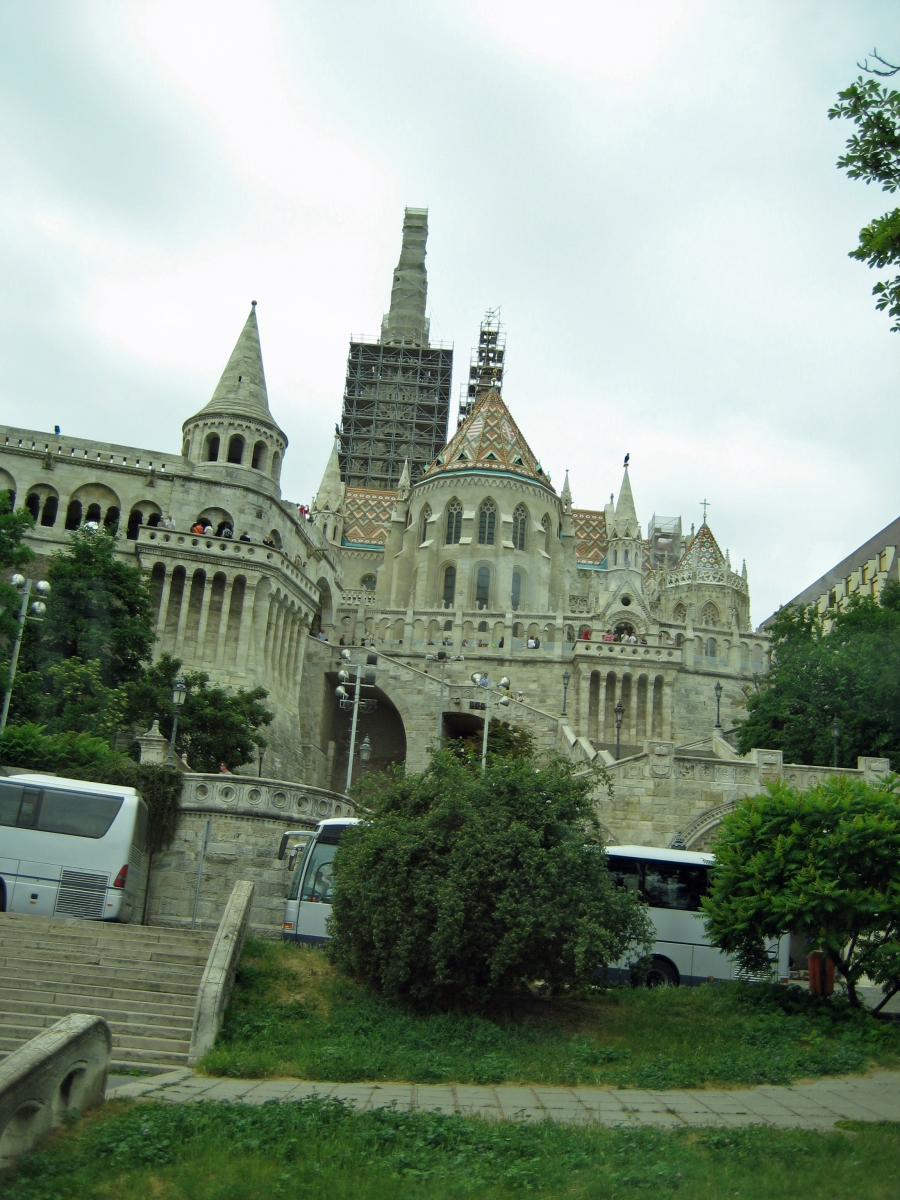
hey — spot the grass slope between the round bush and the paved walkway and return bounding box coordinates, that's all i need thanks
[202,942,900,1088]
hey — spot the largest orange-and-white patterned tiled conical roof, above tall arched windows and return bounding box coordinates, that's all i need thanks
[422,391,553,491]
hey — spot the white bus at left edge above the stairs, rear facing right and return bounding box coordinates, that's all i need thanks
[0,775,148,922]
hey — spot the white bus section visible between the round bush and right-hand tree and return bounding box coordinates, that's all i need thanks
[606,846,791,988]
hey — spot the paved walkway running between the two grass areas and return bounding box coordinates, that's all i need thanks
[107,1070,900,1129]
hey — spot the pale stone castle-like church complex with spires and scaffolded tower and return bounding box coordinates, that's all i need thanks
[0,210,844,841]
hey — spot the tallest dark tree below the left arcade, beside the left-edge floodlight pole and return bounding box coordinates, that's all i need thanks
[32,526,156,688]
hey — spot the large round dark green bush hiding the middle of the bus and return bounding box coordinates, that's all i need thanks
[329,750,650,1007]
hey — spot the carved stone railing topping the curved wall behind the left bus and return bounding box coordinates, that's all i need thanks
[181,772,356,826]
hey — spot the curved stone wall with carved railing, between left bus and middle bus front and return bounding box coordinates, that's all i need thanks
[145,774,355,937]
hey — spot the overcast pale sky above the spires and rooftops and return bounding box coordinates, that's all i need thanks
[0,0,900,622]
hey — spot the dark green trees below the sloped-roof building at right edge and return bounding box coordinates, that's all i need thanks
[738,584,900,766]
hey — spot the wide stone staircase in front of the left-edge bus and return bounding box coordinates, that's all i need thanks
[0,913,214,1070]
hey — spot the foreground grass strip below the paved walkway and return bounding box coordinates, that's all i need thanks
[0,1100,900,1200]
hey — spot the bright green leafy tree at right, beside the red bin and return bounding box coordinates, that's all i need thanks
[703,775,900,1007]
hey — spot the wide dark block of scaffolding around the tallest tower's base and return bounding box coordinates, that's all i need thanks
[338,337,454,490]
